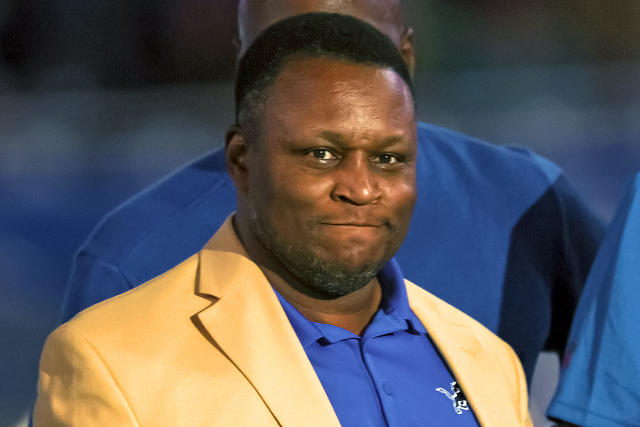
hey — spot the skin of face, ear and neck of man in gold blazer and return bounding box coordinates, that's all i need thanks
[226,57,417,334]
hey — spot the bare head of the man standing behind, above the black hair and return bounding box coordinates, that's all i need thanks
[236,0,415,75]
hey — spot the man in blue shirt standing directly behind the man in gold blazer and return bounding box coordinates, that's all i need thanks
[63,0,602,378]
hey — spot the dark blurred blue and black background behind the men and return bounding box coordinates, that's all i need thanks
[0,0,640,426]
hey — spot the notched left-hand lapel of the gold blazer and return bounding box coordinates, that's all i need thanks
[192,218,340,426]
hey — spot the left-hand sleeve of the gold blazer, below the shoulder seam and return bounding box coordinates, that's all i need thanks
[34,325,139,427]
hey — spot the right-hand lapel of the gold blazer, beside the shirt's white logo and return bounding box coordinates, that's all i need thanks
[407,284,518,427]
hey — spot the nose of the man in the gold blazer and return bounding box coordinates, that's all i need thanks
[331,154,381,206]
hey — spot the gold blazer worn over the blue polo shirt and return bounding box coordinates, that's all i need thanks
[34,219,532,427]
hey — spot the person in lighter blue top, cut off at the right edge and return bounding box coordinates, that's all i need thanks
[548,175,640,427]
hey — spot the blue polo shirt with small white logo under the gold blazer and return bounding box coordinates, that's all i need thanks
[276,260,478,427]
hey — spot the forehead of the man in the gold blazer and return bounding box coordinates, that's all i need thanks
[261,57,415,137]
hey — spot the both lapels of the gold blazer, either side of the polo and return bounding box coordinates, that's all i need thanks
[196,217,519,427]
